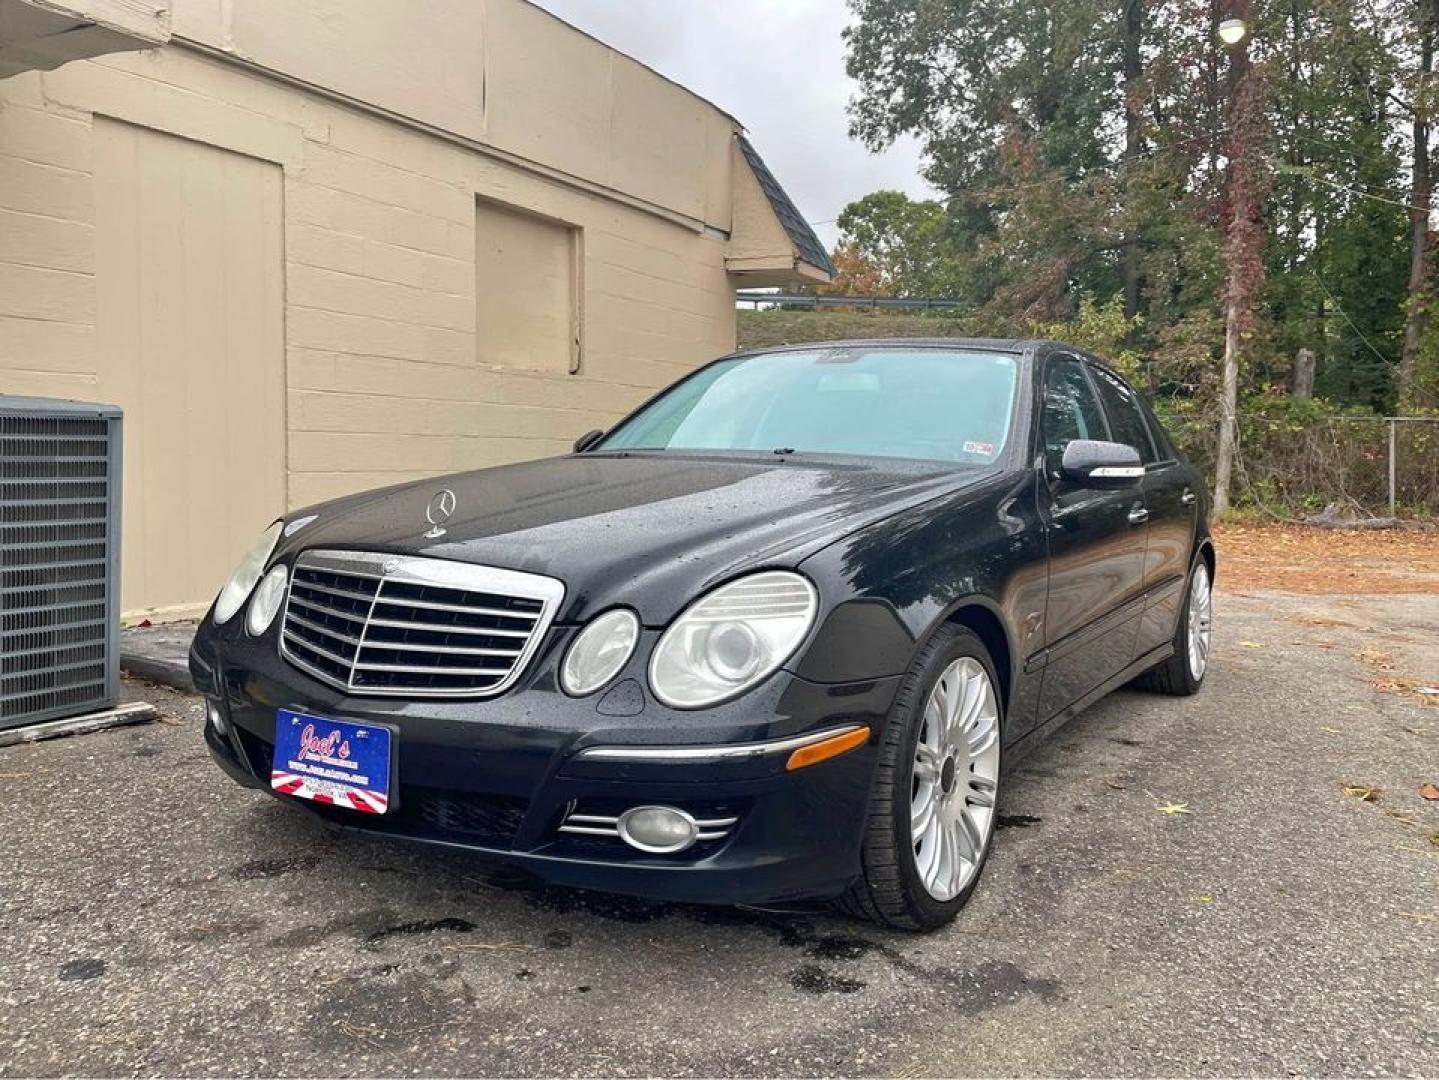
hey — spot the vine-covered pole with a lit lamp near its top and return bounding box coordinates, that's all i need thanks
[1215,0,1262,515]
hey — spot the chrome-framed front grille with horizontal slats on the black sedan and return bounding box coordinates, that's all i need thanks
[281,551,564,697]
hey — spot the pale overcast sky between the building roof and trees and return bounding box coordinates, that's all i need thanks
[537,0,932,247]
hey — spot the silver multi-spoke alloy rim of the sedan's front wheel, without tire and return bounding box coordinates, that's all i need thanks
[909,656,999,902]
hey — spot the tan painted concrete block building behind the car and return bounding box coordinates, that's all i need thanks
[0,0,832,618]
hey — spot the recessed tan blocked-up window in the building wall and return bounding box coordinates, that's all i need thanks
[475,198,581,375]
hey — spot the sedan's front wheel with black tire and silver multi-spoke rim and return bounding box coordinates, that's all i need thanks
[836,626,1004,930]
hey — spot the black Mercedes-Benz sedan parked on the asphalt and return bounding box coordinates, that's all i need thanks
[190,339,1215,929]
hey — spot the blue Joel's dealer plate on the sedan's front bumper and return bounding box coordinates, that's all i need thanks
[271,709,390,814]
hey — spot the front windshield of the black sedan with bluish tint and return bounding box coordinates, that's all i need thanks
[599,348,1017,465]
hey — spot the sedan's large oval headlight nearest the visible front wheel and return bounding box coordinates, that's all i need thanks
[649,569,819,709]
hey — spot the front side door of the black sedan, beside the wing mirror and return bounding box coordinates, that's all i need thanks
[1040,352,1147,719]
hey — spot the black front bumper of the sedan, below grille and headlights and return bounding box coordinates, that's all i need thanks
[190,620,898,903]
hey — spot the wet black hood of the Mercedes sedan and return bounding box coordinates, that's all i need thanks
[281,453,991,626]
